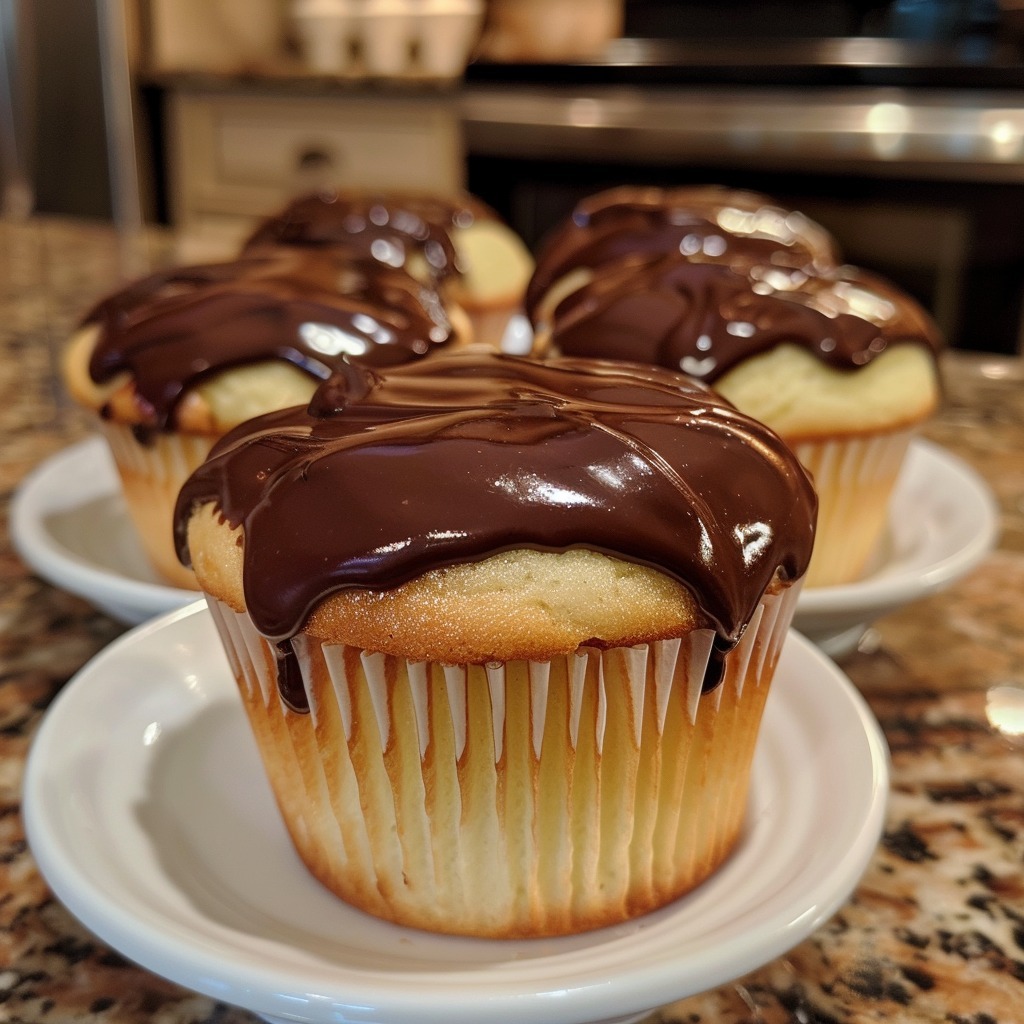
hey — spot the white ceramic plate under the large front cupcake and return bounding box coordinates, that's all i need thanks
[24,604,888,1024]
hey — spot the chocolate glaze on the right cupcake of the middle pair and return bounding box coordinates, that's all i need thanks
[551,255,940,382]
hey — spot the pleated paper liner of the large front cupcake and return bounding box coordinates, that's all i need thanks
[209,586,799,937]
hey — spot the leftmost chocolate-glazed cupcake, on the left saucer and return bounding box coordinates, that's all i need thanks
[63,247,468,588]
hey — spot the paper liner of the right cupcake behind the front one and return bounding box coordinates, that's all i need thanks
[792,430,914,587]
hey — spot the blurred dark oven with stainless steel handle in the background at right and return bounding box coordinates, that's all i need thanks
[462,28,1024,352]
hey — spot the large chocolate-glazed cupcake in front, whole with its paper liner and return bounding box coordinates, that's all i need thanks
[175,351,815,938]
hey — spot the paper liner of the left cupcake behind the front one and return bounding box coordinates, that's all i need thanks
[99,420,216,590]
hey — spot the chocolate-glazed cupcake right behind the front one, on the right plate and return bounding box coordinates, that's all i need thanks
[544,254,940,587]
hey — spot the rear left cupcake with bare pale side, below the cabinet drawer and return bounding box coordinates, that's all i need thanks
[244,190,534,347]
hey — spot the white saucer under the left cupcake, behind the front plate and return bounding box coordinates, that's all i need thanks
[10,436,198,626]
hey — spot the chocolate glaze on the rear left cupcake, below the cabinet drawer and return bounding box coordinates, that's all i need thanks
[244,191,494,281]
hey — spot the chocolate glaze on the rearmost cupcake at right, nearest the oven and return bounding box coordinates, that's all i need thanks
[524,185,840,324]
